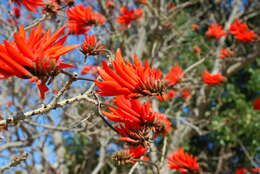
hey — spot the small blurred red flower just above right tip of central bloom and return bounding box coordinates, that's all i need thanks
[165,65,184,86]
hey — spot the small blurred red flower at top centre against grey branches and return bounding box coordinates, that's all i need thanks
[117,7,143,26]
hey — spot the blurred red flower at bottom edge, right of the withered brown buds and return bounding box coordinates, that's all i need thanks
[167,148,200,174]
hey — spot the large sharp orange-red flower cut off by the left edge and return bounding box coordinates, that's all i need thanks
[0,25,78,99]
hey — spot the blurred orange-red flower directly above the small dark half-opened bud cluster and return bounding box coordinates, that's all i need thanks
[67,4,106,34]
